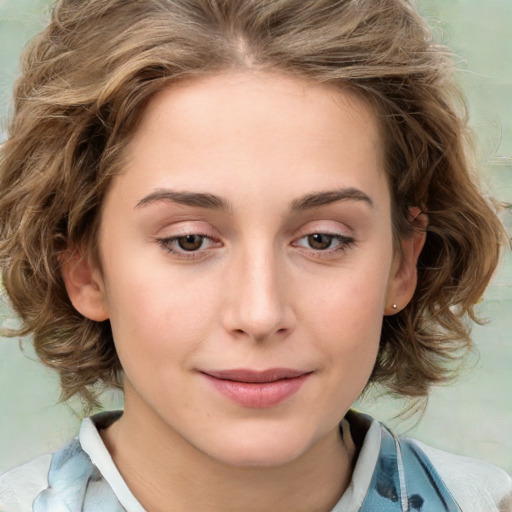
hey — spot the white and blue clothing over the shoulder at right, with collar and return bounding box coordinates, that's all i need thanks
[344,411,512,512]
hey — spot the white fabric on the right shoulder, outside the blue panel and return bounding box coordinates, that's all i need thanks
[410,440,512,512]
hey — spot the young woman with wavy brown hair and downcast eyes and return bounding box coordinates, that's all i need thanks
[0,0,512,512]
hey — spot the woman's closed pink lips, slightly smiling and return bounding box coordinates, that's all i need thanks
[201,368,312,408]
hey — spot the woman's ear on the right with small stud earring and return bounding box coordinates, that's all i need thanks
[384,207,428,315]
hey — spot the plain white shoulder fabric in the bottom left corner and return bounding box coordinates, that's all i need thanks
[0,454,52,512]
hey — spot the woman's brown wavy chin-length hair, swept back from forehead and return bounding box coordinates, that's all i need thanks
[0,0,504,403]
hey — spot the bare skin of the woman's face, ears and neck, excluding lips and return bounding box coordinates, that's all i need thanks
[63,72,424,511]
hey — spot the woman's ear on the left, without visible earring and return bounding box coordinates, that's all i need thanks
[60,250,109,322]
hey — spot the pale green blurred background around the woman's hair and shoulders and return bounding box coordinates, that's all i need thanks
[0,0,512,472]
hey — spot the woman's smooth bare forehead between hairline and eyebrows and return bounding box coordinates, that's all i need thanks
[110,72,385,210]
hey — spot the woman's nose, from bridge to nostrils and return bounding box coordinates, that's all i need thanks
[223,245,295,342]
